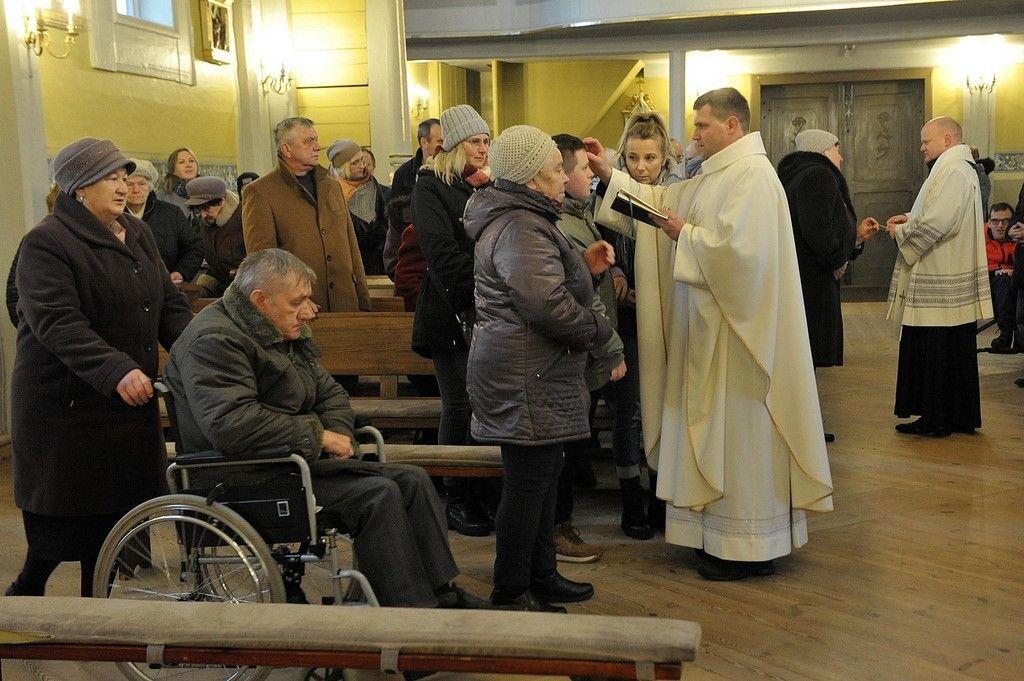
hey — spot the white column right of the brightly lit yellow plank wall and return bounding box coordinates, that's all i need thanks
[367,0,412,183]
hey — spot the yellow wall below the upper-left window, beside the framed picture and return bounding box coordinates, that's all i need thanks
[36,3,238,165]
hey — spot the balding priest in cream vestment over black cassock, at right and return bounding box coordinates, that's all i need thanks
[886,116,992,437]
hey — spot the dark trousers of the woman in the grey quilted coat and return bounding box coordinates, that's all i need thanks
[495,443,564,594]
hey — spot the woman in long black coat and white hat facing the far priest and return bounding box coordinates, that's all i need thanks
[778,130,879,367]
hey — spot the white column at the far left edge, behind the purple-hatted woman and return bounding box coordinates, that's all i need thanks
[0,0,48,438]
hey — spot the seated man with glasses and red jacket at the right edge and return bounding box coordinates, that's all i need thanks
[985,203,1021,351]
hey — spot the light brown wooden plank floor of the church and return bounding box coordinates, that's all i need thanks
[0,303,1024,681]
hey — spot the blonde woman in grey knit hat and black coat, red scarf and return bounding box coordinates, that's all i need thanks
[413,104,490,537]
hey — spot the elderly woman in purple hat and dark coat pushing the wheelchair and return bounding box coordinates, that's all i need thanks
[6,137,191,596]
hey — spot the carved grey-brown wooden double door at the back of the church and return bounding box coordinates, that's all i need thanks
[761,81,925,300]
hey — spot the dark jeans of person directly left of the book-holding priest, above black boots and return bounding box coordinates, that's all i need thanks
[604,334,644,479]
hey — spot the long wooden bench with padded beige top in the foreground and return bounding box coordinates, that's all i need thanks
[0,596,700,681]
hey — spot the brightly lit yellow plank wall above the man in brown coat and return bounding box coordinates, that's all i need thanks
[291,0,372,145]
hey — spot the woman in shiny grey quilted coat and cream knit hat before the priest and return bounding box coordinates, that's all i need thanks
[465,125,614,611]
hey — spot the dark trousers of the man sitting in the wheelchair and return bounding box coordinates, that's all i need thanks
[310,459,459,607]
